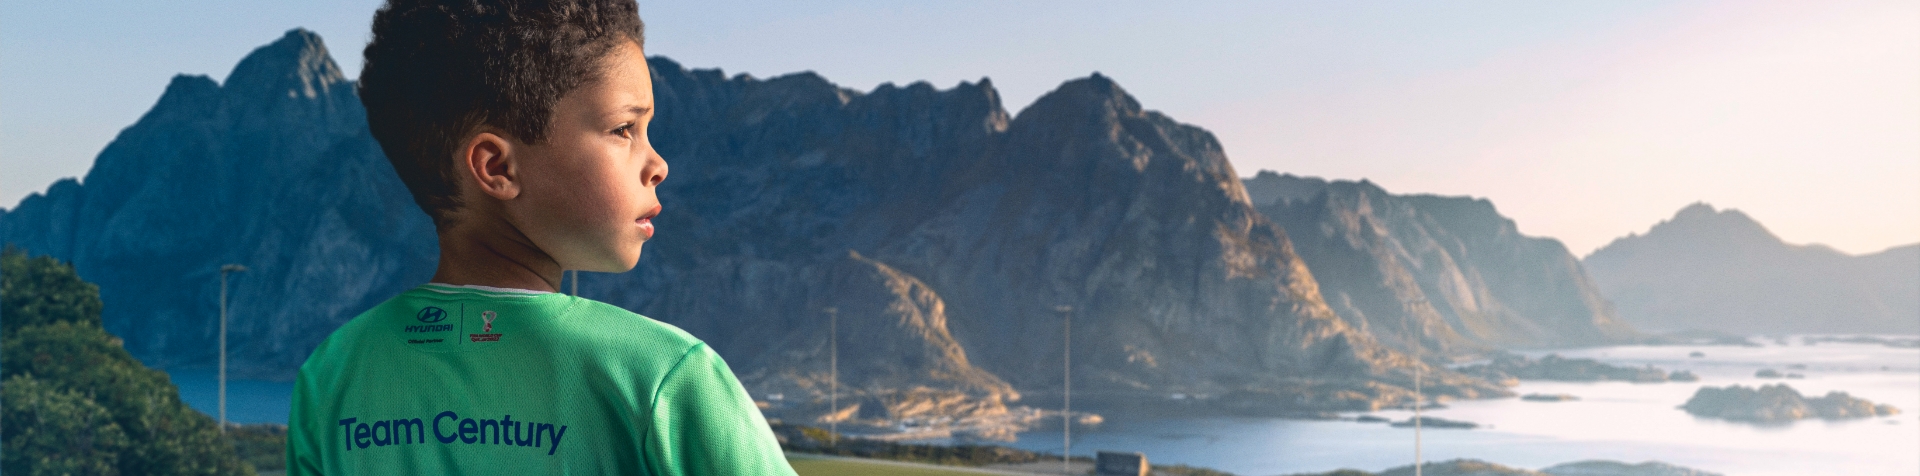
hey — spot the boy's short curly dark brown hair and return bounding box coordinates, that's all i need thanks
[359,0,645,225]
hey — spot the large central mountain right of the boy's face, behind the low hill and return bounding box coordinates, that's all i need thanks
[599,60,1443,399]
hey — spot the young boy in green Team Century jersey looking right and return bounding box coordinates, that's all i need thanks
[286,0,793,474]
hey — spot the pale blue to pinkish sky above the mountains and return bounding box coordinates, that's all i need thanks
[0,0,1920,255]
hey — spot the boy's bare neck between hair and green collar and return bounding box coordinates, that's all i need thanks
[432,226,561,292]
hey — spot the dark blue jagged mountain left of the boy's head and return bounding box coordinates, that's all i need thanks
[0,29,438,376]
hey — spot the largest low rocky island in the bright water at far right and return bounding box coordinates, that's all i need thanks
[1680,384,1901,424]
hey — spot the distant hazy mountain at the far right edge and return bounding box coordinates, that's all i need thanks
[1582,203,1920,334]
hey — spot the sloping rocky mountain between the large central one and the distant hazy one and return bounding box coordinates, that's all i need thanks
[1246,171,1638,355]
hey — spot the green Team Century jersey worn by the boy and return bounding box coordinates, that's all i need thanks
[286,284,793,474]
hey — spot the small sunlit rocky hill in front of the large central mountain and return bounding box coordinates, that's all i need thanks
[739,251,1020,436]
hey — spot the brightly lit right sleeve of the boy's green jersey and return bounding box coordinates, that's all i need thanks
[643,344,793,476]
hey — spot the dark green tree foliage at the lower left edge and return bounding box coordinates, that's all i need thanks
[0,248,253,474]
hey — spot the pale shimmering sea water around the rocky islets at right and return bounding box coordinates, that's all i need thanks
[1014,342,1920,476]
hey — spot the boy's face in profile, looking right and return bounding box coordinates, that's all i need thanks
[505,42,666,273]
